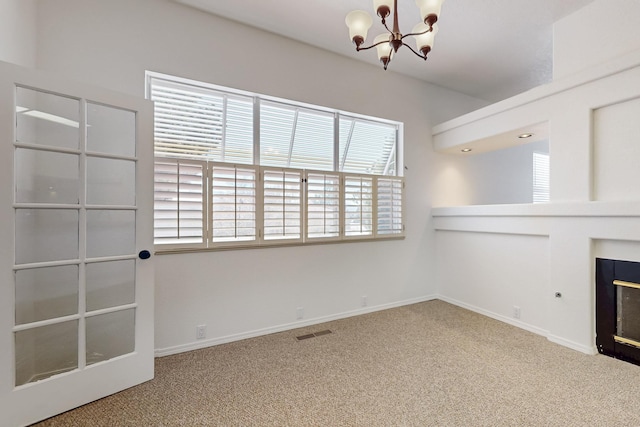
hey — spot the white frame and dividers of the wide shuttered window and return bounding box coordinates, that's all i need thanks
[146,71,406,253]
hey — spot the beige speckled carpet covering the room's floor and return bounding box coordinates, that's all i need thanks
[33,301,640,427]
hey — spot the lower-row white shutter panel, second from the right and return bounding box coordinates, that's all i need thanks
[344,175,373,237]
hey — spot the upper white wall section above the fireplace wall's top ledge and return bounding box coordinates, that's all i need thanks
[553,0,640,80]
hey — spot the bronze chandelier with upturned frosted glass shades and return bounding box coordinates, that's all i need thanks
[345,0,444,70]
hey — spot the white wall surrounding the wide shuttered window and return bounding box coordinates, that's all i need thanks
[32,0,484,354]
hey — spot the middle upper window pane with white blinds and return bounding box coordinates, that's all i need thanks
[260,102,334,170]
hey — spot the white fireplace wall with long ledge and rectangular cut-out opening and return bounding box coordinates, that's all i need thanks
[432,1,640,353]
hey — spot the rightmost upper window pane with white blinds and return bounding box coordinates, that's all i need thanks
[338,116,398,175]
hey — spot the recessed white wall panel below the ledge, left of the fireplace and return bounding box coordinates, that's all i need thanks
[436,230,549,333]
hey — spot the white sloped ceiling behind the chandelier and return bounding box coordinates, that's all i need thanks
[176,0,593,102]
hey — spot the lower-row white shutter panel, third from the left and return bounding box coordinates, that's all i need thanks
[263,168,302,241]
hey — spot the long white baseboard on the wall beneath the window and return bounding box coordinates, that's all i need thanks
[155,295,438,357]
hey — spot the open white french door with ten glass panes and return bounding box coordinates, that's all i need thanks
[0,63,153,426]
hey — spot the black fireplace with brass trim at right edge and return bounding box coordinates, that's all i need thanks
[596,258,640,365]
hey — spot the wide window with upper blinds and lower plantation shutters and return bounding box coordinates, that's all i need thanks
[147,73,404,250]
